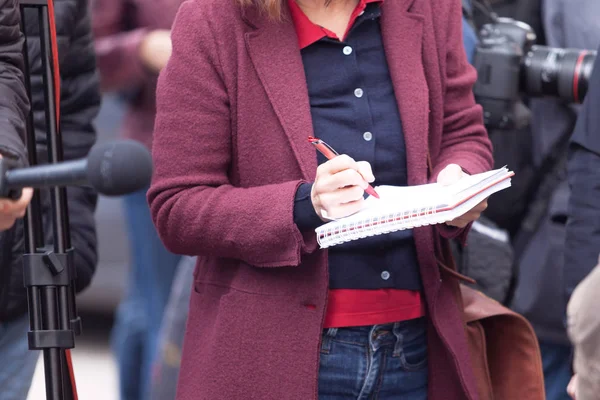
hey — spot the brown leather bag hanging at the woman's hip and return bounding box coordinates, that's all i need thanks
[437,238,546,400]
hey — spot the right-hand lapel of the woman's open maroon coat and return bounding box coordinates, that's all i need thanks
[381,0,429,185]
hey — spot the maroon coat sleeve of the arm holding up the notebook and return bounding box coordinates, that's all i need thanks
[431,1,493,239]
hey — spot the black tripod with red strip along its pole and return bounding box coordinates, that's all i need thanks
[20,0,81,400]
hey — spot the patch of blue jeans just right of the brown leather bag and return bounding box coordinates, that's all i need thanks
[540,342,573,400]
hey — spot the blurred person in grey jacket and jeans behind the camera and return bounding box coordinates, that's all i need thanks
[502,0,600,400]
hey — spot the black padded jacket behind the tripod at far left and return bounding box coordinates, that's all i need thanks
[0,0,100,320]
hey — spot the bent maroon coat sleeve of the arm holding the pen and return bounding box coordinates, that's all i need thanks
[148,2,314,267]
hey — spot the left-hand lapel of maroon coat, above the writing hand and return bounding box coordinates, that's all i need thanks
[245,8,317,180]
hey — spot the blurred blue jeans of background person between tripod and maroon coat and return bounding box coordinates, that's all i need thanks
[112,190,181,400]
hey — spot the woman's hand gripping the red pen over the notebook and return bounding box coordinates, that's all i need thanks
[310,155,375,220]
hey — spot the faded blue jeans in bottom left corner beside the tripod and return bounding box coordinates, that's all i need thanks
[0,314,40,400]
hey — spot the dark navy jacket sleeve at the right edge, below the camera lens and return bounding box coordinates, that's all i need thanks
[564,46,600,306]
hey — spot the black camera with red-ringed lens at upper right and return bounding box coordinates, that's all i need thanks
[473,18,596,129]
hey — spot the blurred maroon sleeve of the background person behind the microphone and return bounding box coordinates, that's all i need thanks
[92,0,156,91]
